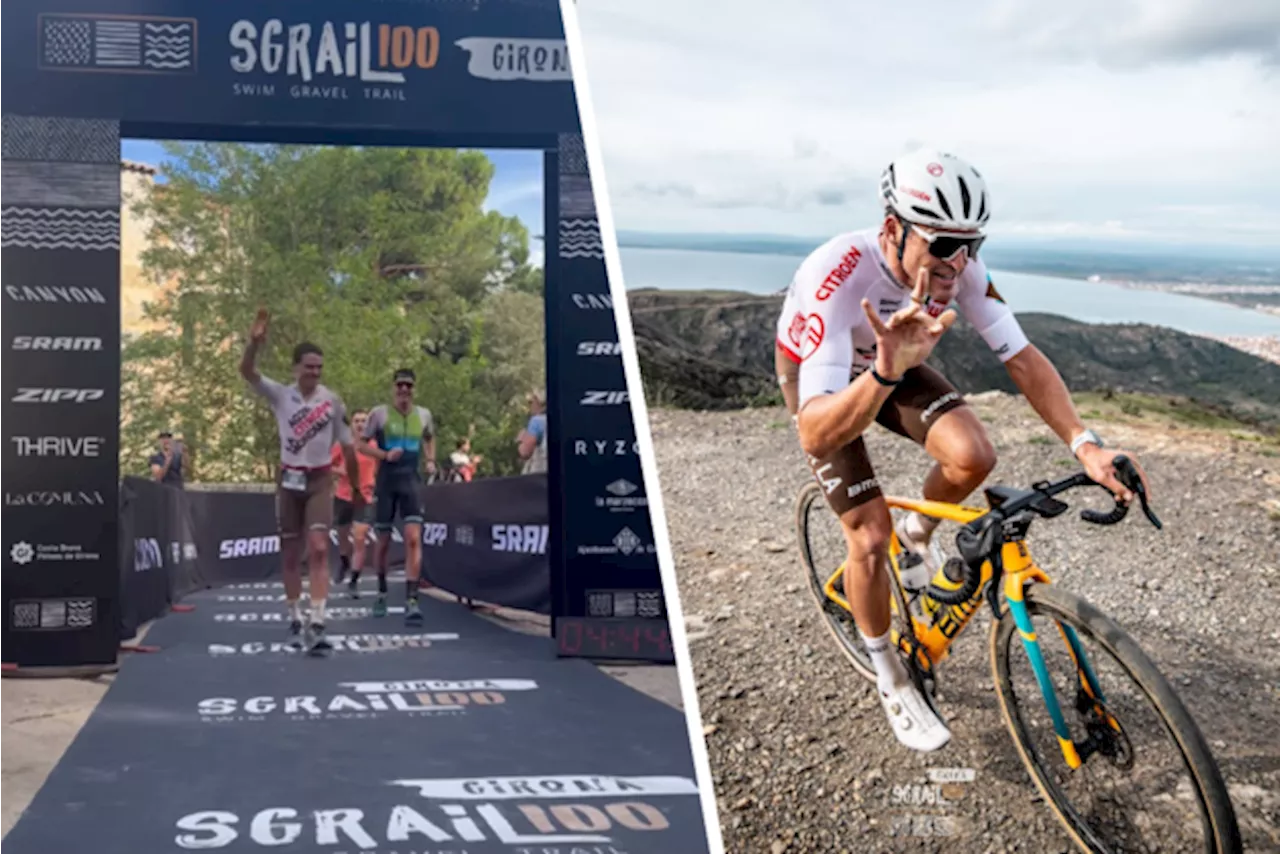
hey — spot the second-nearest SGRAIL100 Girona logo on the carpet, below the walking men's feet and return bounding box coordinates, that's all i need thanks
[196,679,538,723]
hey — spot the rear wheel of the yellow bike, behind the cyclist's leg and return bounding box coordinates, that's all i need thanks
[796,481,876,685]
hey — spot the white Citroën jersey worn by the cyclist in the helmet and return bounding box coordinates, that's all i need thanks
[777,227,1028,406]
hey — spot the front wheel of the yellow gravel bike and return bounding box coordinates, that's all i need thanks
[991,584,1242,854]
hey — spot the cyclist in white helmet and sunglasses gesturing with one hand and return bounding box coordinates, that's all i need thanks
[776,150,1146,752]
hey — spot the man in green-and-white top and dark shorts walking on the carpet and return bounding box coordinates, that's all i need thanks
[356,367,435,625]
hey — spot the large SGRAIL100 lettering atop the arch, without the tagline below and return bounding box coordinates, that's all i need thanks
[228,18,440,83]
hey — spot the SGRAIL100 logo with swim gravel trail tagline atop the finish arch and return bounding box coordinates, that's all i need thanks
[227,18,440,101]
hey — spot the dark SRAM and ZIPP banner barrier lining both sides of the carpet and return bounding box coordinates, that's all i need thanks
[119,475,550,639]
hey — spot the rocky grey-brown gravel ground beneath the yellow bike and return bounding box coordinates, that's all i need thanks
[650,392,1280,854]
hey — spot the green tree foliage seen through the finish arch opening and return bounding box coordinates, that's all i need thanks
[122,143,544,483]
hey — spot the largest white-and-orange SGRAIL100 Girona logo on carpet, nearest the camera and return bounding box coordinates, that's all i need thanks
[174,775,700,854]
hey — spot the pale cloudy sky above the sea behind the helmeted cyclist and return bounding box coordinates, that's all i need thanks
[577,0,1280,246]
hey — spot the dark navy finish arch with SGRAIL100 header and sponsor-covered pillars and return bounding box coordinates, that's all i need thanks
[0,0,672,667]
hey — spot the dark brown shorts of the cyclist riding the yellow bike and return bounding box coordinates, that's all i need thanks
[809,365,965,516]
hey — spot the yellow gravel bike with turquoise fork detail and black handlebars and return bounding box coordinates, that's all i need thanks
[796,456,1242,854]
